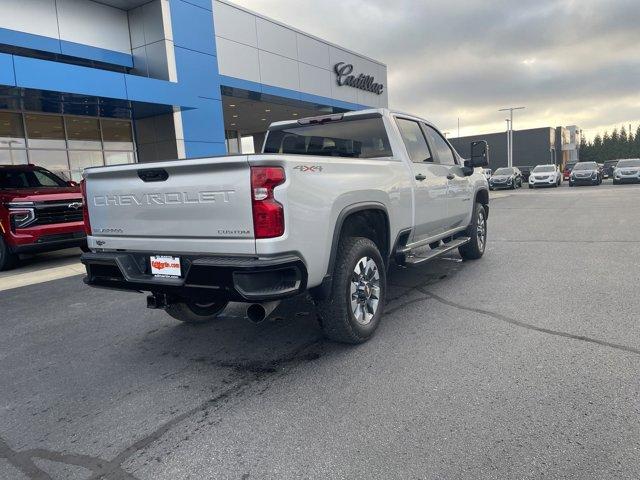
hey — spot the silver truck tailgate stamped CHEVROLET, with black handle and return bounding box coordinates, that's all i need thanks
[85,156,255,254]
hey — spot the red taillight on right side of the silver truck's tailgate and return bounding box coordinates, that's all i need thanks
[251,167,286,238]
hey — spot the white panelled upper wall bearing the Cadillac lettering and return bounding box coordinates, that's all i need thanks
[213,0,387,107]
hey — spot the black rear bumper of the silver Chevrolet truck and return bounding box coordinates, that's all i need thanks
[81,252,307,302]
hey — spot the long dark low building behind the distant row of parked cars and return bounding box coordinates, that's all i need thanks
[449,125,580,170]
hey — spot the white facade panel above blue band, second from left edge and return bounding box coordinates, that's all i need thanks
[57,0,131,54]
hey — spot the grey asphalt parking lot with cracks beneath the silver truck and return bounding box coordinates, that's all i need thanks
[0,184,640,480]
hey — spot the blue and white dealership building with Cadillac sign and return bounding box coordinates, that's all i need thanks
[0,0,388,179]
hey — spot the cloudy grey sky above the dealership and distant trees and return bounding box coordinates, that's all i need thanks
[228,0,640,136]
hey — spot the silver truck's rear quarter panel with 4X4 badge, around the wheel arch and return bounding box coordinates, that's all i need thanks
[249,155,412,287]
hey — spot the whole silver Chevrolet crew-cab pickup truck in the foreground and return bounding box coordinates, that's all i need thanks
[82,109,489,343]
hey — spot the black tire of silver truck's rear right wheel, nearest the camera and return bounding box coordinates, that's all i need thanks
[318,237,387,344]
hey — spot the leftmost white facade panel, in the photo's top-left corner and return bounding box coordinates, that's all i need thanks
[0,0,58,38]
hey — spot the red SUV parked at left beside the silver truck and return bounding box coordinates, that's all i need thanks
[0,165,86,270]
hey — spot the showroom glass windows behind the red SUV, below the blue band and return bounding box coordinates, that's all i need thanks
[0,111,136,181]
